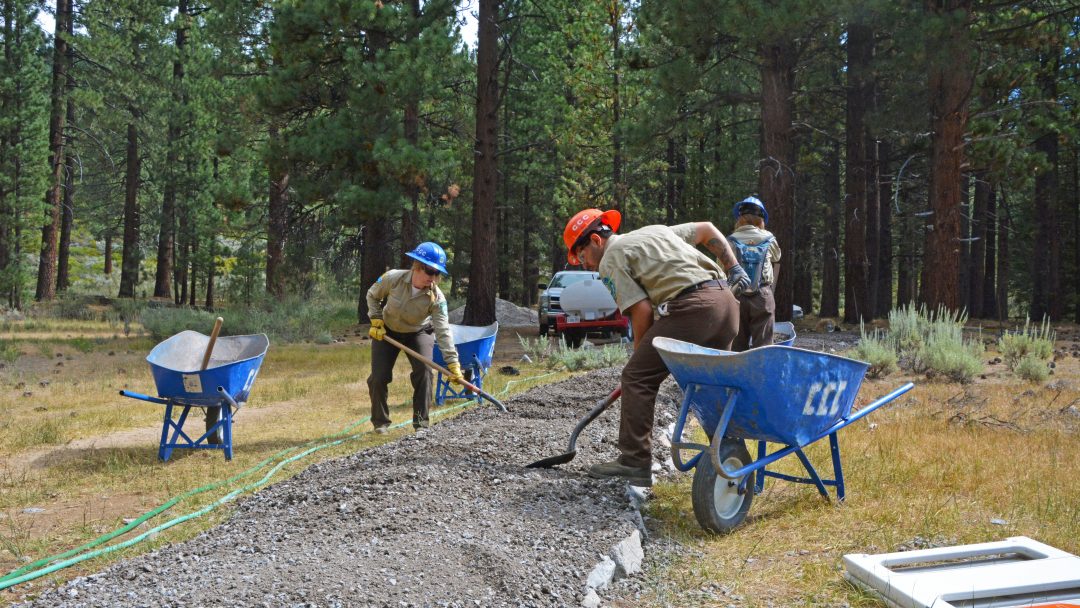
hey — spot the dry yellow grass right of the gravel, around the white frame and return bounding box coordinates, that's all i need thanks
[643,360,1080,607]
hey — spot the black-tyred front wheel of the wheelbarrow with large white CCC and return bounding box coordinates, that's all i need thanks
[691,438,754,535]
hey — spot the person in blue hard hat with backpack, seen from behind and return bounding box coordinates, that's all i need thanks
[728,197,780,352]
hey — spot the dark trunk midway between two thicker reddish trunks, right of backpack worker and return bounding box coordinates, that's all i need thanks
[843,23,874,323]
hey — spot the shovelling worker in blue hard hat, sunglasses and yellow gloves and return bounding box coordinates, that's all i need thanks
[367,242,464,433]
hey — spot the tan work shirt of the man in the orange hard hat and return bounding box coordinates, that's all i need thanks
[598,224,723,312]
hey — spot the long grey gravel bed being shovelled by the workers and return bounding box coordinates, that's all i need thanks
[14,369,677,607]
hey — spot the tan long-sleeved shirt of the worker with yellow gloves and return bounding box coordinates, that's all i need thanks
[367,270,458,364]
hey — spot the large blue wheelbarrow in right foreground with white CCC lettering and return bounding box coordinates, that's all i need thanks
[652,338,915,533]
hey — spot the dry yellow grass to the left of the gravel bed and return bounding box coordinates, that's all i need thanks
[0,324,565,604]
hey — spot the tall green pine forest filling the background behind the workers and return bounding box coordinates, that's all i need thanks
[0,0,1080,324]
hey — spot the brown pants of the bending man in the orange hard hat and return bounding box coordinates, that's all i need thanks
[619,286,739,468]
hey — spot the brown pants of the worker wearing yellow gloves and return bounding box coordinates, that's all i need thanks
[367,329,435,429]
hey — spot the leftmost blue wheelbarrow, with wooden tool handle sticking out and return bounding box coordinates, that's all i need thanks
[120,327,270,461]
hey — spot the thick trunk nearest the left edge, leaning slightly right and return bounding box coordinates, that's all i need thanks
[35,0,71,301]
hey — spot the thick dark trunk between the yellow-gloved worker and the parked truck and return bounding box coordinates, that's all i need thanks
[464,0,500,325]
